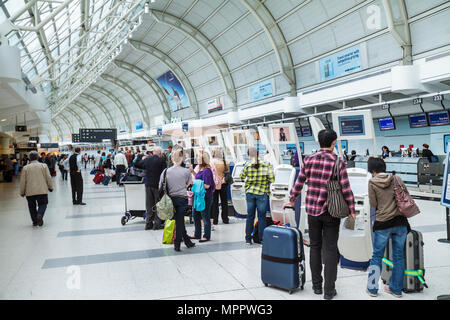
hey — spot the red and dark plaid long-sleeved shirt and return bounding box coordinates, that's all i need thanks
[290,149,355,216]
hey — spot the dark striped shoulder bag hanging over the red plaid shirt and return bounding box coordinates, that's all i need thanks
[327,156,350,219]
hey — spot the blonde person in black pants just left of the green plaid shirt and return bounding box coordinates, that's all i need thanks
[211,148,230,225]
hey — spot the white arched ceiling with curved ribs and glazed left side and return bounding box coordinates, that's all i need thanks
[0,0,450,140]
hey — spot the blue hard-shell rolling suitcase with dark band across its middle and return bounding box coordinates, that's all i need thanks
[261,206,306,294]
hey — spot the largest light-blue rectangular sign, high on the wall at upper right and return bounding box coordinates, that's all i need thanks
[319,45,362,81]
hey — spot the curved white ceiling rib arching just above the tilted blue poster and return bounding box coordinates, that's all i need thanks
[129,40,200,119]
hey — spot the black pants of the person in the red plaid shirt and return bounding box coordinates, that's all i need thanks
[308,212,340,294]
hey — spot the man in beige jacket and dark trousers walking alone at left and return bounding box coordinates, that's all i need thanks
[20,151,53,227]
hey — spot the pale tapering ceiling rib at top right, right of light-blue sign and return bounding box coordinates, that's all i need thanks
[383,0,412,65]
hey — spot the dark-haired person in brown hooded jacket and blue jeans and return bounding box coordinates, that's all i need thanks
[367,157,411,298]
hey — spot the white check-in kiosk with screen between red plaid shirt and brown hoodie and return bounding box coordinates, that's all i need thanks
[332,110,376,270]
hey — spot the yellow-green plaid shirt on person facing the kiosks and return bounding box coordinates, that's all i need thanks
[241,159,275,195]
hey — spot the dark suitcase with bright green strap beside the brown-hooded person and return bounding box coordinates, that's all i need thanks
[381,230,428,293]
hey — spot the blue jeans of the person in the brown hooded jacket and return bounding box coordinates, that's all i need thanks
[367,226,408,295]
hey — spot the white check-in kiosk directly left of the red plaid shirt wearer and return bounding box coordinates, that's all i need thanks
[269,123,300,227]
